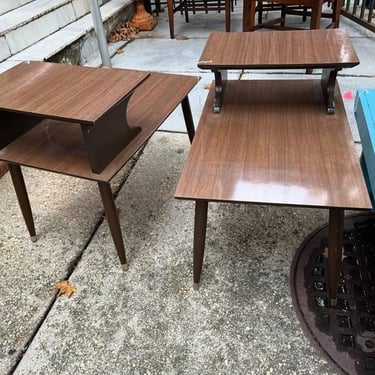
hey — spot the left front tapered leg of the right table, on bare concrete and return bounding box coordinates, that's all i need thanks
[193,200,208,289]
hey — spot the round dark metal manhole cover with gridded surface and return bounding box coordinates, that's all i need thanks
[290,214,375,375]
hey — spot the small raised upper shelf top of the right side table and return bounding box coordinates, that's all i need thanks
[198,29,359,70]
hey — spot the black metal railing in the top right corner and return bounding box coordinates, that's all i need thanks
[341,0,375,32]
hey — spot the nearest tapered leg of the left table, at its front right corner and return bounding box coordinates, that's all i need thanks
[98,182,129,271]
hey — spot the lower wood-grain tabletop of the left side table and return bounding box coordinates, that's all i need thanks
[0,73,198,182]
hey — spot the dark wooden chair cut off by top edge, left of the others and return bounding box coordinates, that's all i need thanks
[167,0,232,39]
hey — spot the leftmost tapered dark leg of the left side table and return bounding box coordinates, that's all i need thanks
[8,164,37,242]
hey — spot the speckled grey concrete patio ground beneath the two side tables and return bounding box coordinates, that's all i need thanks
[0,4,375,375]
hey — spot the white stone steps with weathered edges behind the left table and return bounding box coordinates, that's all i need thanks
[0,0,134,177]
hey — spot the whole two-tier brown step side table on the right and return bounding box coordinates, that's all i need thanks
[175,30,372,305]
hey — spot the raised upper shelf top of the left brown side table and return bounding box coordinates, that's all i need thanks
[0,61,149,124]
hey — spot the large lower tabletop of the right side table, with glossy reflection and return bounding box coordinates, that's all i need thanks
[176,80,372,209]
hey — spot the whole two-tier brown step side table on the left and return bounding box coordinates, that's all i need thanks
[0,62,198,269]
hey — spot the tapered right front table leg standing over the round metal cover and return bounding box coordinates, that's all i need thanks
[328,208,344,306]
